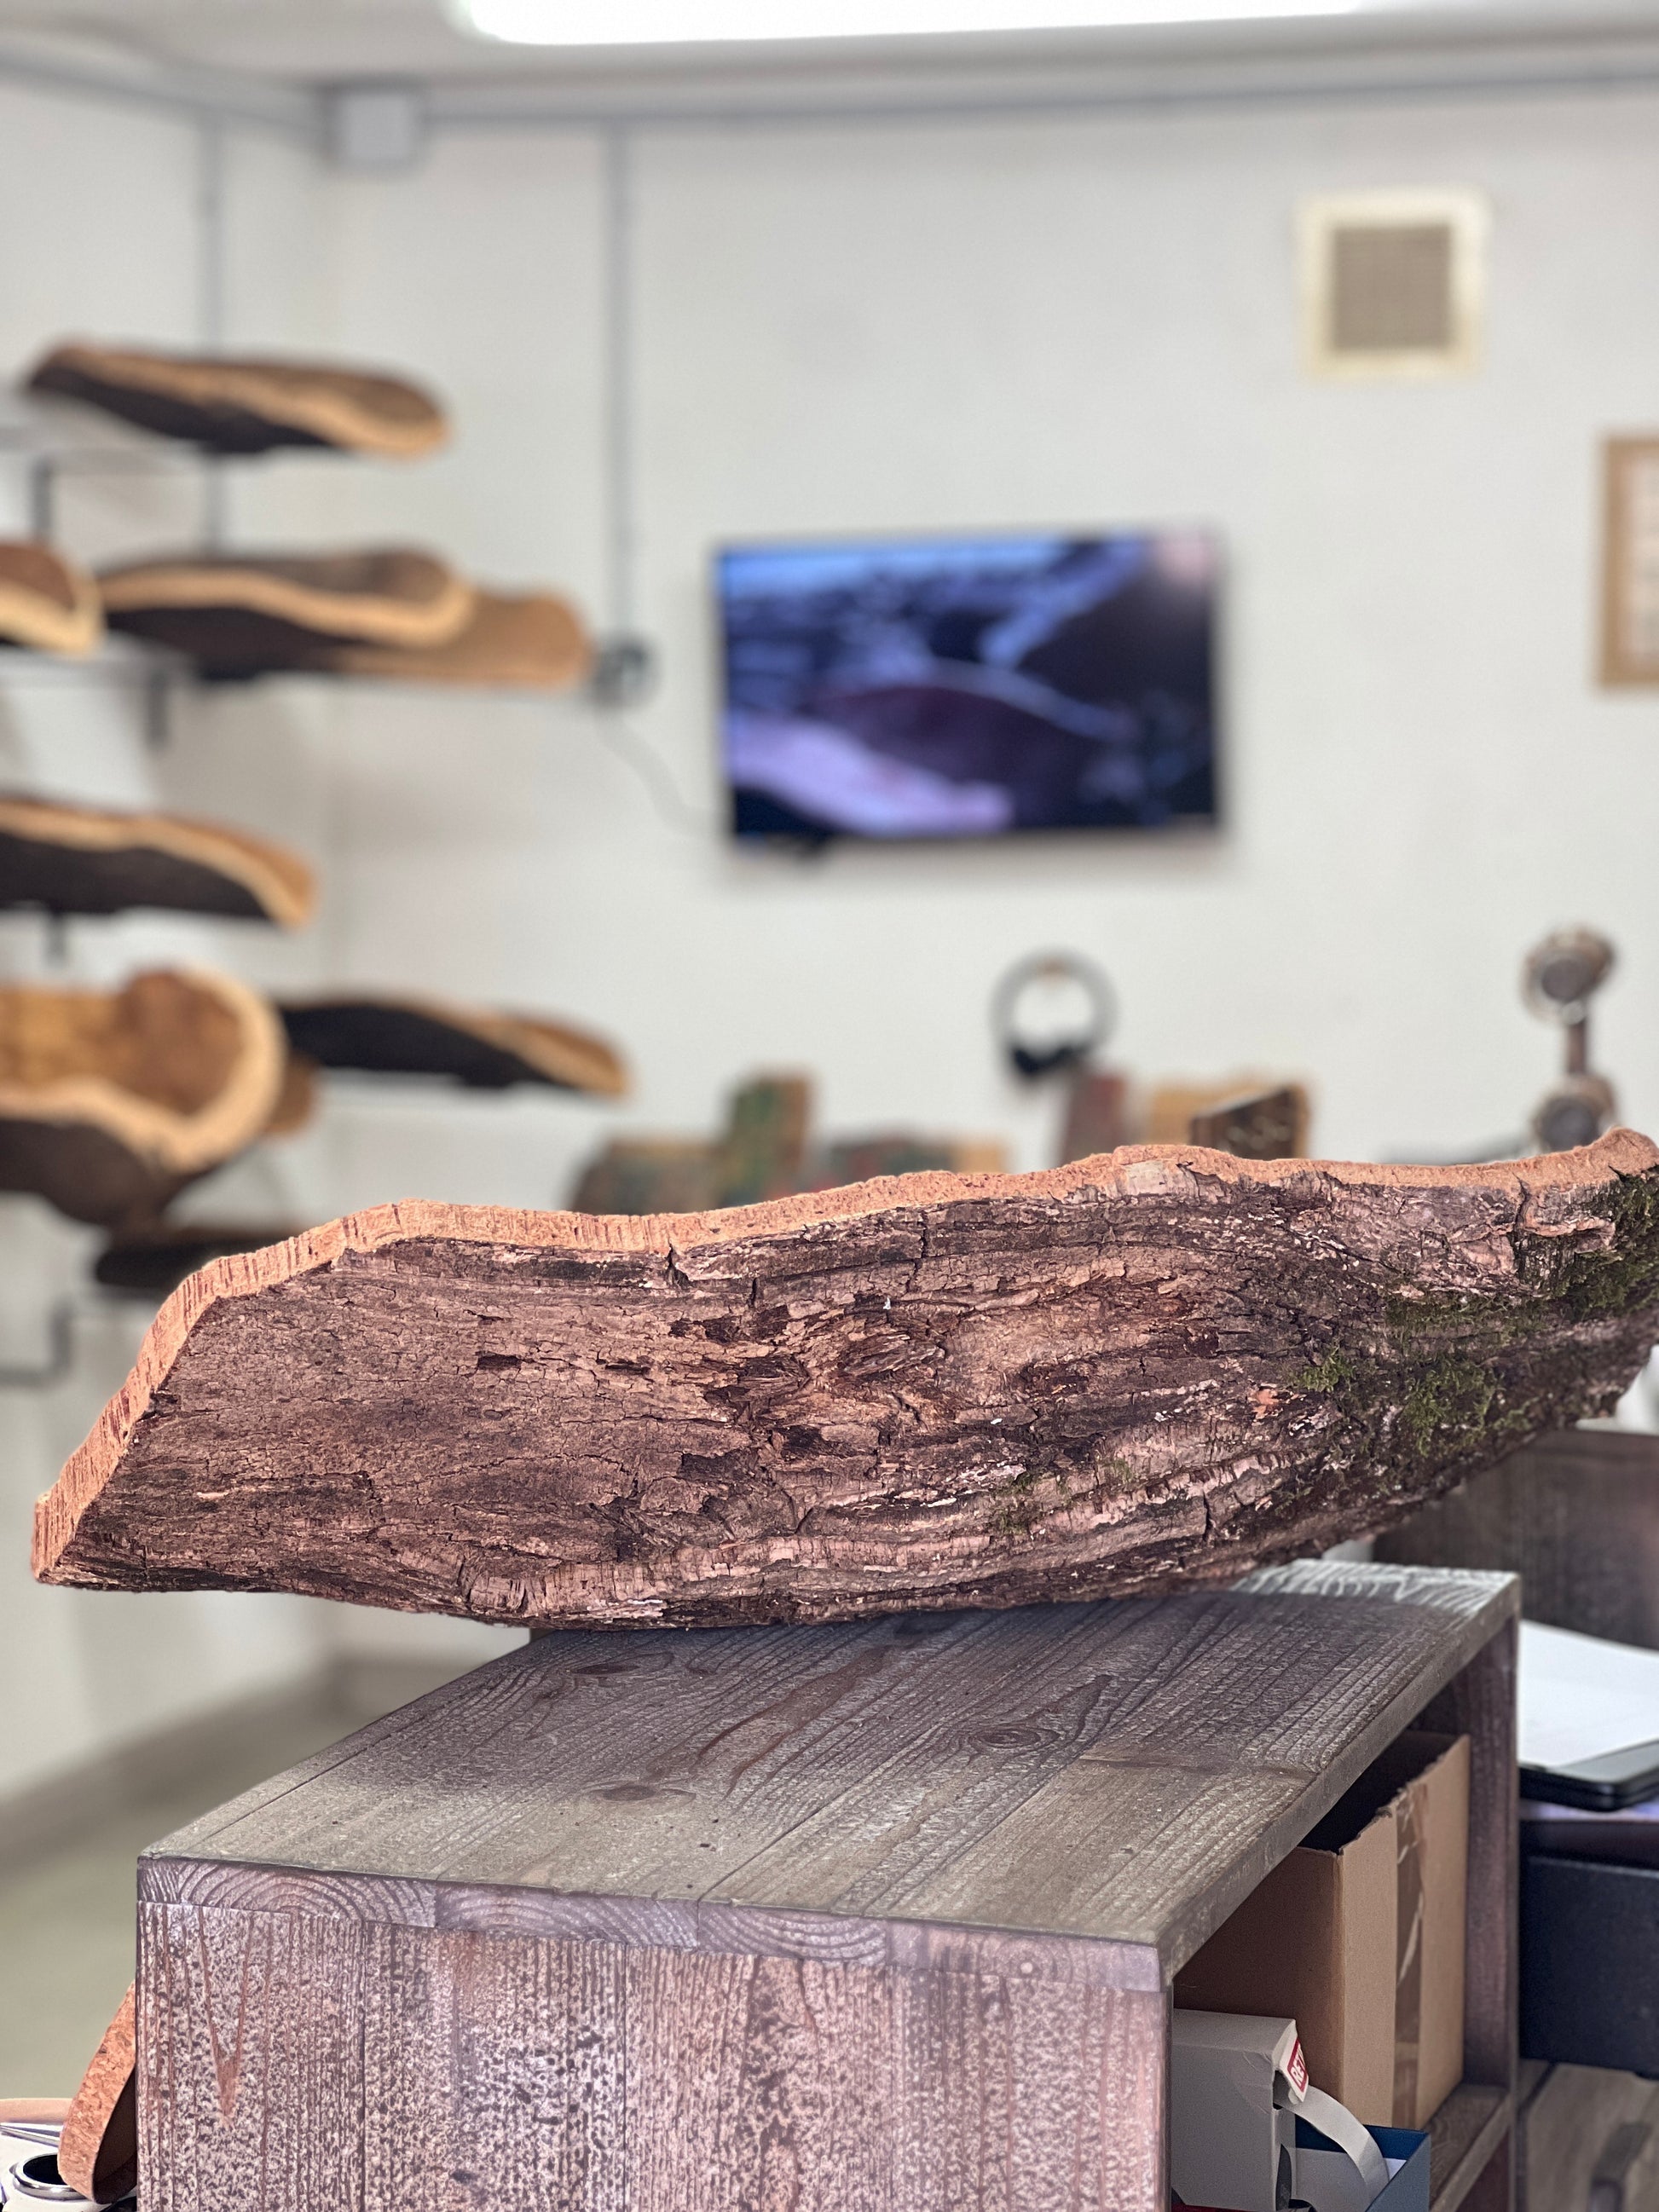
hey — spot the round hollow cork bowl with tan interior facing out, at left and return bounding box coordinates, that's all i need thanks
[0,969,287,1227]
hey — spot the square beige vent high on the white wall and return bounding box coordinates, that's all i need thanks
[1301,193,1487,376]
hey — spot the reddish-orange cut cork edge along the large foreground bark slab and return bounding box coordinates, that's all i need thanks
[31,1128,1659,1581]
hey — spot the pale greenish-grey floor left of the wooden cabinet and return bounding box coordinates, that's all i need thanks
[0,1666,464,2097]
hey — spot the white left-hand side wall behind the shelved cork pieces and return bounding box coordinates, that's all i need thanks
[0,89,333,1792]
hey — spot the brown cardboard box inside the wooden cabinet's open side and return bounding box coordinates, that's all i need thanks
[1175,1730,1469,2128]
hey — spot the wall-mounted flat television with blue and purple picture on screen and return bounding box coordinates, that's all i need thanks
[714,531,1219,840]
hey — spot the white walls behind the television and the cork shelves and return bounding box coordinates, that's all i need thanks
[0,64,1659,1772]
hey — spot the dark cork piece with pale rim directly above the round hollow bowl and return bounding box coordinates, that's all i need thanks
[0,792,316,929]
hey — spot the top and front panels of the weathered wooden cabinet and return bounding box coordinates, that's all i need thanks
[139,1566,1515,2212]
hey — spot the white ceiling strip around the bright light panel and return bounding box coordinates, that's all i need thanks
[0,0,1659,84]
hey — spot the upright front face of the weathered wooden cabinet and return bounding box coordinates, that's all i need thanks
[139,1904,1165,2212]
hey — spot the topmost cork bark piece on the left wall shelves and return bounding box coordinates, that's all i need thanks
[29,341,449,460]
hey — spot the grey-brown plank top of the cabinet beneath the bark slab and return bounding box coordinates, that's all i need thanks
[142,1564,1515,1980]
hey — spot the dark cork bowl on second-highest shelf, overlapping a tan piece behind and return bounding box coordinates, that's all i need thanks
[97,546,476,679]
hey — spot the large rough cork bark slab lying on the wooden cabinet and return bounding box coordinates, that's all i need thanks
[36,1130,1659,1626]
